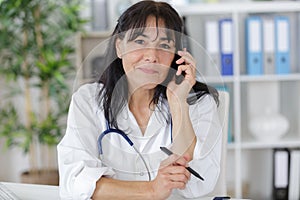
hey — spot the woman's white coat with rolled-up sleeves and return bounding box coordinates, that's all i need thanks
[57,83,222,199]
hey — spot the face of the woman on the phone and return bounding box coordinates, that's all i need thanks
[116,16,176,90]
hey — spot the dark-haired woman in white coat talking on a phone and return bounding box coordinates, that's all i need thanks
[58,1,221,199]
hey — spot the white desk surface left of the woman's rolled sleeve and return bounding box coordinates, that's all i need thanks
[1,182,60,200]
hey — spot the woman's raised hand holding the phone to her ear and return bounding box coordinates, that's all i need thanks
[167,49,196,102]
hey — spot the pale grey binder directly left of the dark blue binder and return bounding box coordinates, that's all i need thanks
[205,20,220,76]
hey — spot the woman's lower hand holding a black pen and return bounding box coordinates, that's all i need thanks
[151,154,191,199]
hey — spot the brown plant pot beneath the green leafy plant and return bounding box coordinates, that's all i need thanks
[21,169,59,185]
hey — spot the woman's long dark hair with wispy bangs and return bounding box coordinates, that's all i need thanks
[98,1,218,128]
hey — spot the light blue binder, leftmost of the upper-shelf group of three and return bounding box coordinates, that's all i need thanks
[246,16,263,75]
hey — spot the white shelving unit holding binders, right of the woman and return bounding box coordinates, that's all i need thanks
[176,1,300,199]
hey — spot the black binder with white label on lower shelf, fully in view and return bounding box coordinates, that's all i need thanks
[273,148,290,200]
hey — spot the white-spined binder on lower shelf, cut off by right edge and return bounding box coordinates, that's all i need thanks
[289,149,300,200]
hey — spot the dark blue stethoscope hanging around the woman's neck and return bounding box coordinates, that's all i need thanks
[97,119,173,181]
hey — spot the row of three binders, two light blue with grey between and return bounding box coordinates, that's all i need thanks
[245,16,290,75]
